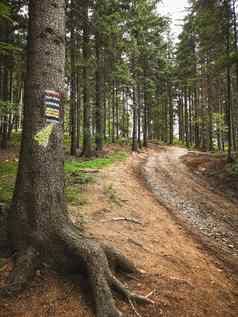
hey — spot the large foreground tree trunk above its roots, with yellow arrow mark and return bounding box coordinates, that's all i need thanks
[6,0,67,253]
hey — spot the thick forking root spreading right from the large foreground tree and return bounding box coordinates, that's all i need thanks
[62,225,153,317]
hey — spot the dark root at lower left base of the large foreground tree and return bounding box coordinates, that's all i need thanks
[0,247,38,297]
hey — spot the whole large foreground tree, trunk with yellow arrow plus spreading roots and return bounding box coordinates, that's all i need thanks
[0,0,152,317]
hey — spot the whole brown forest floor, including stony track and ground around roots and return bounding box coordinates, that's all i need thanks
[0,146,238,317]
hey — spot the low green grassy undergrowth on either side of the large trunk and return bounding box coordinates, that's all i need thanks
[0,152,128,205]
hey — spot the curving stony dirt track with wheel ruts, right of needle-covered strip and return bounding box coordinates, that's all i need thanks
[143,146,238,278]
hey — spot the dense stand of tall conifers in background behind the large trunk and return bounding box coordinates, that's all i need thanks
[0,0,238,160]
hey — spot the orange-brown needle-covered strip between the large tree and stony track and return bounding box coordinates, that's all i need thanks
[69,147,238,317]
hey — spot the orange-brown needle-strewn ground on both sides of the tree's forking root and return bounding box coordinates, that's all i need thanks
[0,150,238,317]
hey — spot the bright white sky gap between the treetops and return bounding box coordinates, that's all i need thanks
[159,0,188,37]
